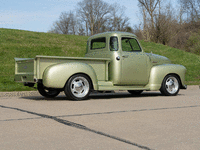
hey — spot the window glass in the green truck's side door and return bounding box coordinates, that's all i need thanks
[122,37,141,52]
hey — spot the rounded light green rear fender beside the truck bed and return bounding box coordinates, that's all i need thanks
[42,62,97,90]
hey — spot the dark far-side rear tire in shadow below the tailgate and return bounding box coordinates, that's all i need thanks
[37,83,60,98]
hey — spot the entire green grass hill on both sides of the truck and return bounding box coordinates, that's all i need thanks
[0,28,200,91]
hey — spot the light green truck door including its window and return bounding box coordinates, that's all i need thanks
[120,37,149,85]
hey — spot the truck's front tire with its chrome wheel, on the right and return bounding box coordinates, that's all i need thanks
[160,75,180,96]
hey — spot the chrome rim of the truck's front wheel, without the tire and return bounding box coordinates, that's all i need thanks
[166,77,179,94]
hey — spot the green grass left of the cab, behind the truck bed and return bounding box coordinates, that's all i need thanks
[0,28,88,91]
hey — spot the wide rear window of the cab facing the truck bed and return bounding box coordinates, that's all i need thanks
[91,37,106,50]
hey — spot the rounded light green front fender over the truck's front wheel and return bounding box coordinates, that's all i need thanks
[148,64,186,90]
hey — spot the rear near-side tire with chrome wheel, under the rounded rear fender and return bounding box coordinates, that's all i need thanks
[64,74,91,101]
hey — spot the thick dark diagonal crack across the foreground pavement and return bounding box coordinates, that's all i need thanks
[0,105,152,150]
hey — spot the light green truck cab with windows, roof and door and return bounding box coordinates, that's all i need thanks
[86,32,150,86]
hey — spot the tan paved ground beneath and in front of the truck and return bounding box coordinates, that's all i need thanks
[0,86,200,150]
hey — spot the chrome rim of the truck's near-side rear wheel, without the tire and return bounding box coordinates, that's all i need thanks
[70,77,89,98]
